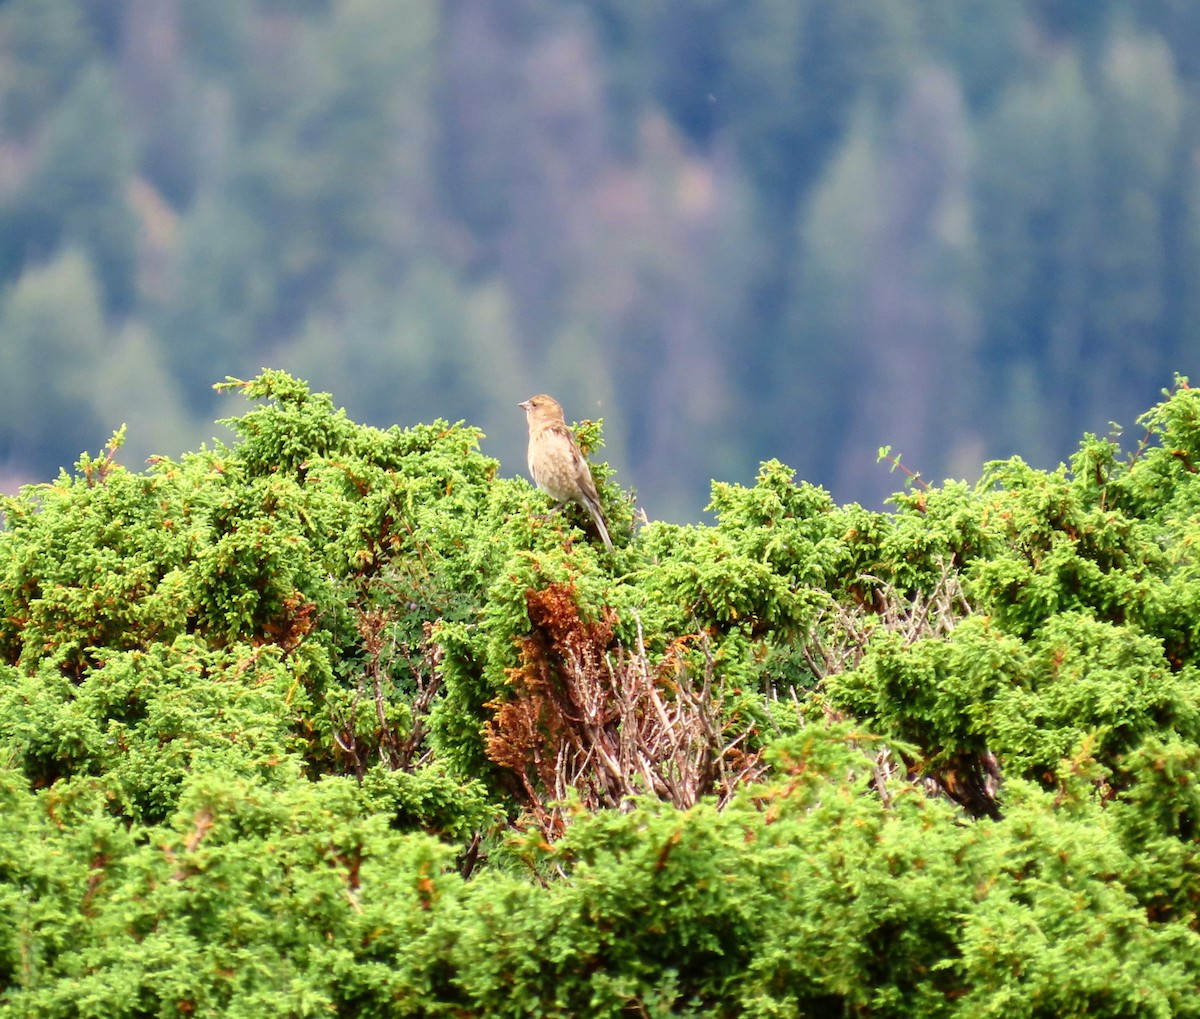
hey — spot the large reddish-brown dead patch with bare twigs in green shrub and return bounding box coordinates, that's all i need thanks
[487,585,763,835]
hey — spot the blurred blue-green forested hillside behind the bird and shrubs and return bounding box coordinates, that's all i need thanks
[0,0,1200,521]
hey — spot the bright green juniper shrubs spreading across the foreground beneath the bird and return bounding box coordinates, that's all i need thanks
[0,372,1200,1019]
